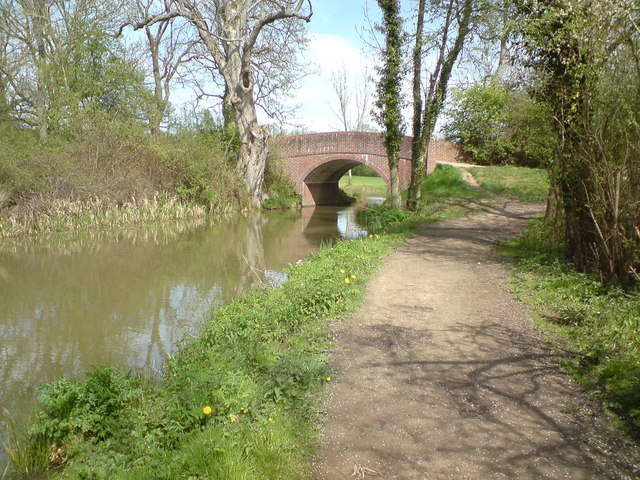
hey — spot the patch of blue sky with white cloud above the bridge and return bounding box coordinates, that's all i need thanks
[276,0,379,132]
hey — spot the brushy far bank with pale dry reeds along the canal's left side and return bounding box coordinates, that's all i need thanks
[0,121,244,238]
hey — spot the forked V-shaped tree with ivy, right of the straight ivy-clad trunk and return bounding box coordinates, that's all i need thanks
[407,0,477,210]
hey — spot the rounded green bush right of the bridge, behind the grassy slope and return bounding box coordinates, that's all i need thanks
[445,83,556,167]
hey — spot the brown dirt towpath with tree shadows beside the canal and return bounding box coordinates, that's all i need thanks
[315,203,640,480]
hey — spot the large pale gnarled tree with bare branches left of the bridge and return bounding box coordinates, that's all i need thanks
[122,0,313,204]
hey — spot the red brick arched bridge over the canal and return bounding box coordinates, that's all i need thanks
[269,132,458,206]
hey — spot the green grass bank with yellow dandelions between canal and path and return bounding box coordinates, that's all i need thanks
[9,235,402,480]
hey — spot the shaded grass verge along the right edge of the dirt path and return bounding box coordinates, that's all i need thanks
[500,220,640,438]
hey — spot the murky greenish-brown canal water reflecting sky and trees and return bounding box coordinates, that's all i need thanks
[0,207,366,458]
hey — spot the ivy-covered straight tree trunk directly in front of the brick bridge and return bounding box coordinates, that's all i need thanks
[376,0,403,208]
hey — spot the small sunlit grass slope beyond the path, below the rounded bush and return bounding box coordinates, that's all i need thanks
[469,166,549,203]
